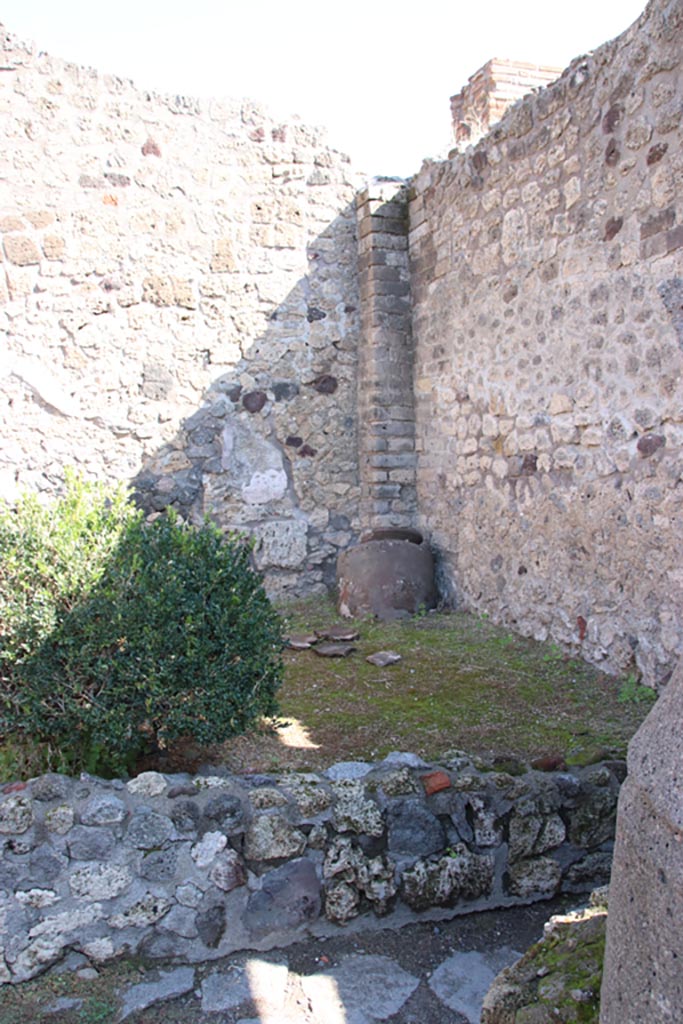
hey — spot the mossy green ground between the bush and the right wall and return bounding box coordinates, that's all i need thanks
[189,600,651,771]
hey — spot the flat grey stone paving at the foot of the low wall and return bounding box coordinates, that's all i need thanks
[29,900,575,1024]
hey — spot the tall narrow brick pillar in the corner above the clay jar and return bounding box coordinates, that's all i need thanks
[356,179,417,528]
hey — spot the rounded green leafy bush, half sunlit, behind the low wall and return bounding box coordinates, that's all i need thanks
[0,477,282,772]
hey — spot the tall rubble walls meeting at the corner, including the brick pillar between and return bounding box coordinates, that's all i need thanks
[0,0,683,687]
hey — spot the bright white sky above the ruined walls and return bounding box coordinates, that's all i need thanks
[0,0,645,176]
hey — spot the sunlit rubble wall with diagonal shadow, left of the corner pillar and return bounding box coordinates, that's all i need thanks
[0,28,359,592]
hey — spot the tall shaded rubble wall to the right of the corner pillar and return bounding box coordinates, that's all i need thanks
[410,0,683,686]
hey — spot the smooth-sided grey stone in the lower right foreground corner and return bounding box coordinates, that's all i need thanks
[600,663,683,1024]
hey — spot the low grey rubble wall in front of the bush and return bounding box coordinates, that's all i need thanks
[0,754,625,983]
